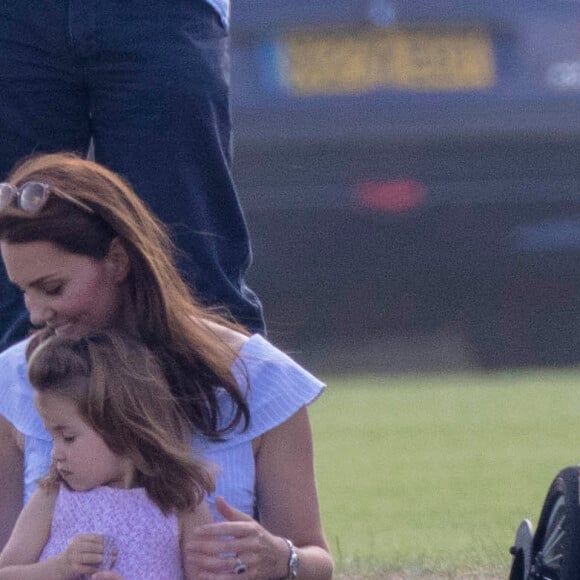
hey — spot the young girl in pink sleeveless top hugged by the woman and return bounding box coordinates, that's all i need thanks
[0,333,213,580]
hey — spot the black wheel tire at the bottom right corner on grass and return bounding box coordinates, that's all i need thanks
[529,467,580,580]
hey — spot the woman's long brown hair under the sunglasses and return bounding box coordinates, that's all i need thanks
[0,153,249,439]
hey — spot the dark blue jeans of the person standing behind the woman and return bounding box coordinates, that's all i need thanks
[0,0,264,348]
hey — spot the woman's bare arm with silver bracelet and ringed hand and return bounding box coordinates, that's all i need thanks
[187,408,333,580]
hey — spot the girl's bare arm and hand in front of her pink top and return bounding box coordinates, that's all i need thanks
[0,488,103,580]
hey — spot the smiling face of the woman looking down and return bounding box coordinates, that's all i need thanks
[0,241,126,338]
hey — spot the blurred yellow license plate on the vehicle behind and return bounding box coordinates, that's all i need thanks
[283,28,495,95]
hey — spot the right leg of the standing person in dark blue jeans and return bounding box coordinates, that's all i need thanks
[86,0,264,332]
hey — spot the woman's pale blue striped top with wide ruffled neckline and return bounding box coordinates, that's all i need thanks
[0,334,325,519]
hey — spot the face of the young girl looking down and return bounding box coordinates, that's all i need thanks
[34,392,135,491]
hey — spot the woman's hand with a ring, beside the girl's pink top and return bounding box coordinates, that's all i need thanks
[185,497,289,580]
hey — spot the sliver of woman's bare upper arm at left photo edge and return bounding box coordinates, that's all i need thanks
[0,417,24,550]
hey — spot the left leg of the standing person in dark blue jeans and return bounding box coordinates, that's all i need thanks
[0,0,89,350]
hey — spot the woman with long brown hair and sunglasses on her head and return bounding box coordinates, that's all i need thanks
[0,154,332,579]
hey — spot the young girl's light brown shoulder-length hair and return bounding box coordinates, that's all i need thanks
[28,333,214,512]
